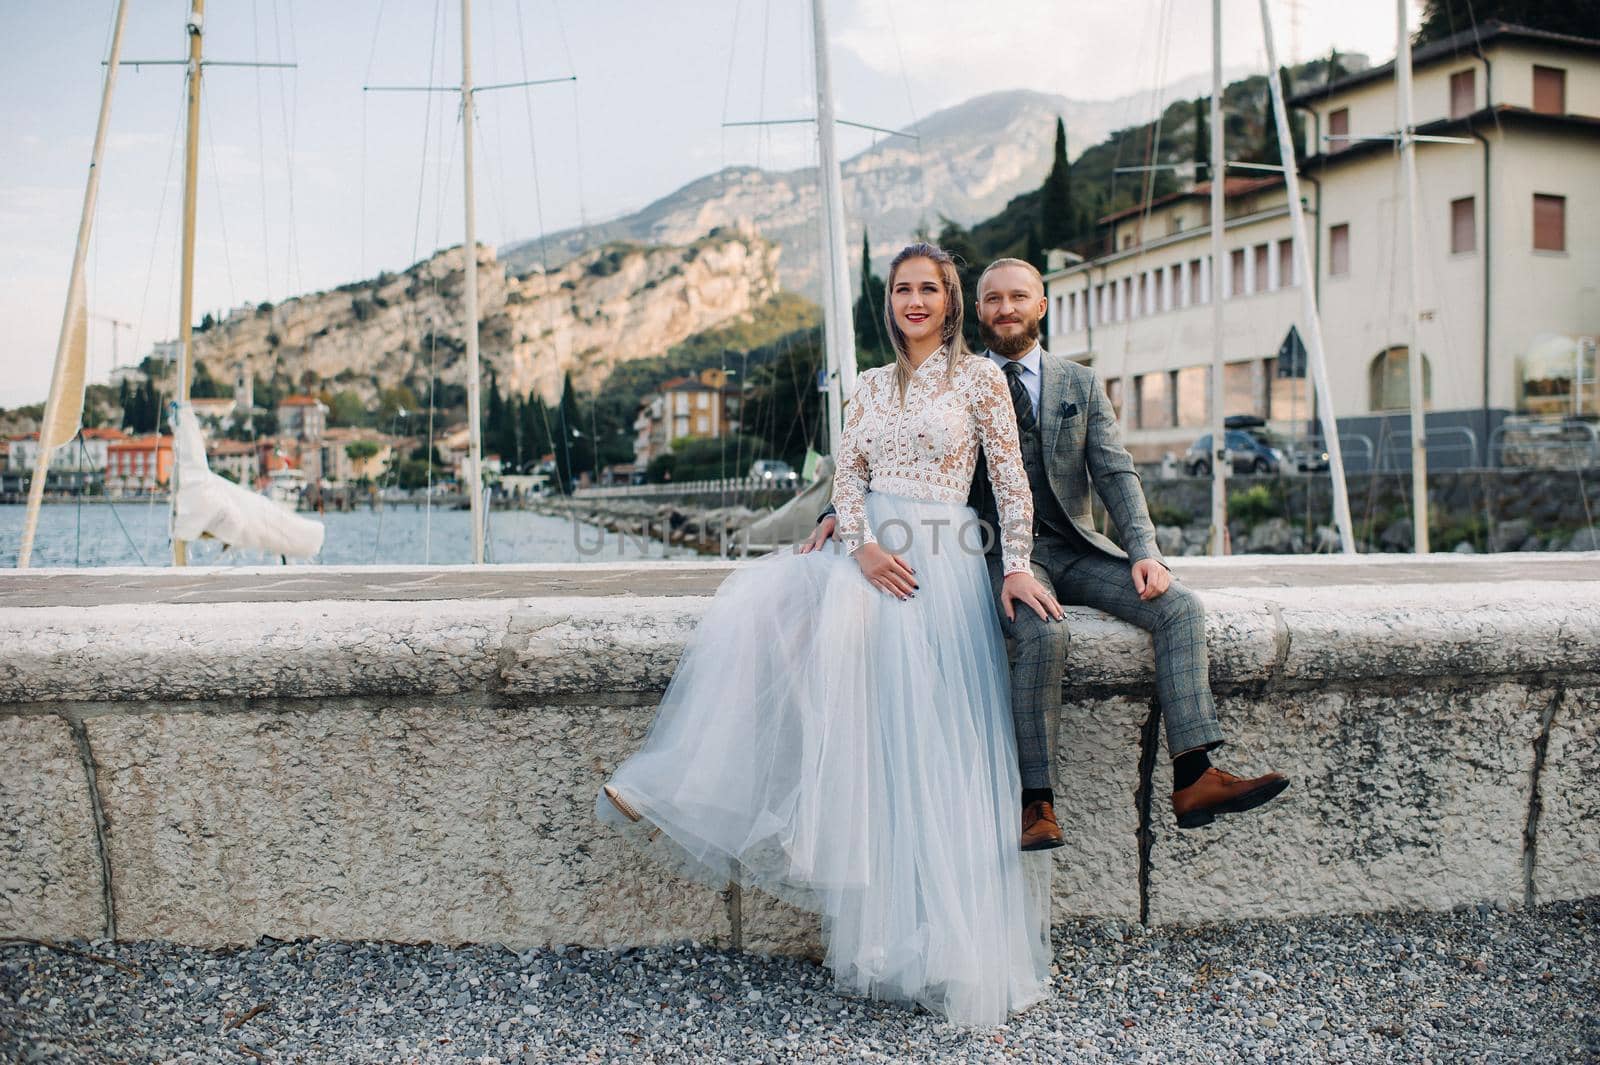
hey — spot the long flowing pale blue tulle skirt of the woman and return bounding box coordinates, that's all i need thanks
[595,493,1050,1025]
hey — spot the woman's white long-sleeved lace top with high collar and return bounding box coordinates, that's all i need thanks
[834,349,1034,574]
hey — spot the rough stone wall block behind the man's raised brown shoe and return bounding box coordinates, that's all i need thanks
[1150,683,1550,924]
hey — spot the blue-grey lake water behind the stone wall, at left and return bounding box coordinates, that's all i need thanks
[0,502,698,569]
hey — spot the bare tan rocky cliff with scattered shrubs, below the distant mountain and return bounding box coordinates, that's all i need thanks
[195,229,779,401]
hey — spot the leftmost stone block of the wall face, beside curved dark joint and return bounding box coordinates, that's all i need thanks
[0,715,106,939]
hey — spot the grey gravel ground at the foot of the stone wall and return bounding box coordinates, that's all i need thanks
[0,899,1600,1065]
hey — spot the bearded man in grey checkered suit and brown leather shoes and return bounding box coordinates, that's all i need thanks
[800,259,1290,851]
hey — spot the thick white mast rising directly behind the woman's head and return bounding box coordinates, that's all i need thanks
[811,0,856,454]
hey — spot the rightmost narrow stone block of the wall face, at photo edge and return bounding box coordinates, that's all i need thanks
[1533,688,1600,900]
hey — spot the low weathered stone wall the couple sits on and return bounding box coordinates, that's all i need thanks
[0,555,1600,951]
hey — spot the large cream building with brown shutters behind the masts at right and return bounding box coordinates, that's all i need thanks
[1046,22,1600,469]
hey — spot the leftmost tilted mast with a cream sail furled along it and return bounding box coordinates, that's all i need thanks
[16,0,128,569]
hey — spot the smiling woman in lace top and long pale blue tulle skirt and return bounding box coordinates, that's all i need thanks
[595,243,1061,1025]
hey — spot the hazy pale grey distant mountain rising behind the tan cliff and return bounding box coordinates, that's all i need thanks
[502,77,1235,294]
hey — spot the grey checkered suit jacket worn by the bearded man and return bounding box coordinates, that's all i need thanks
[966,352,1166,566]
